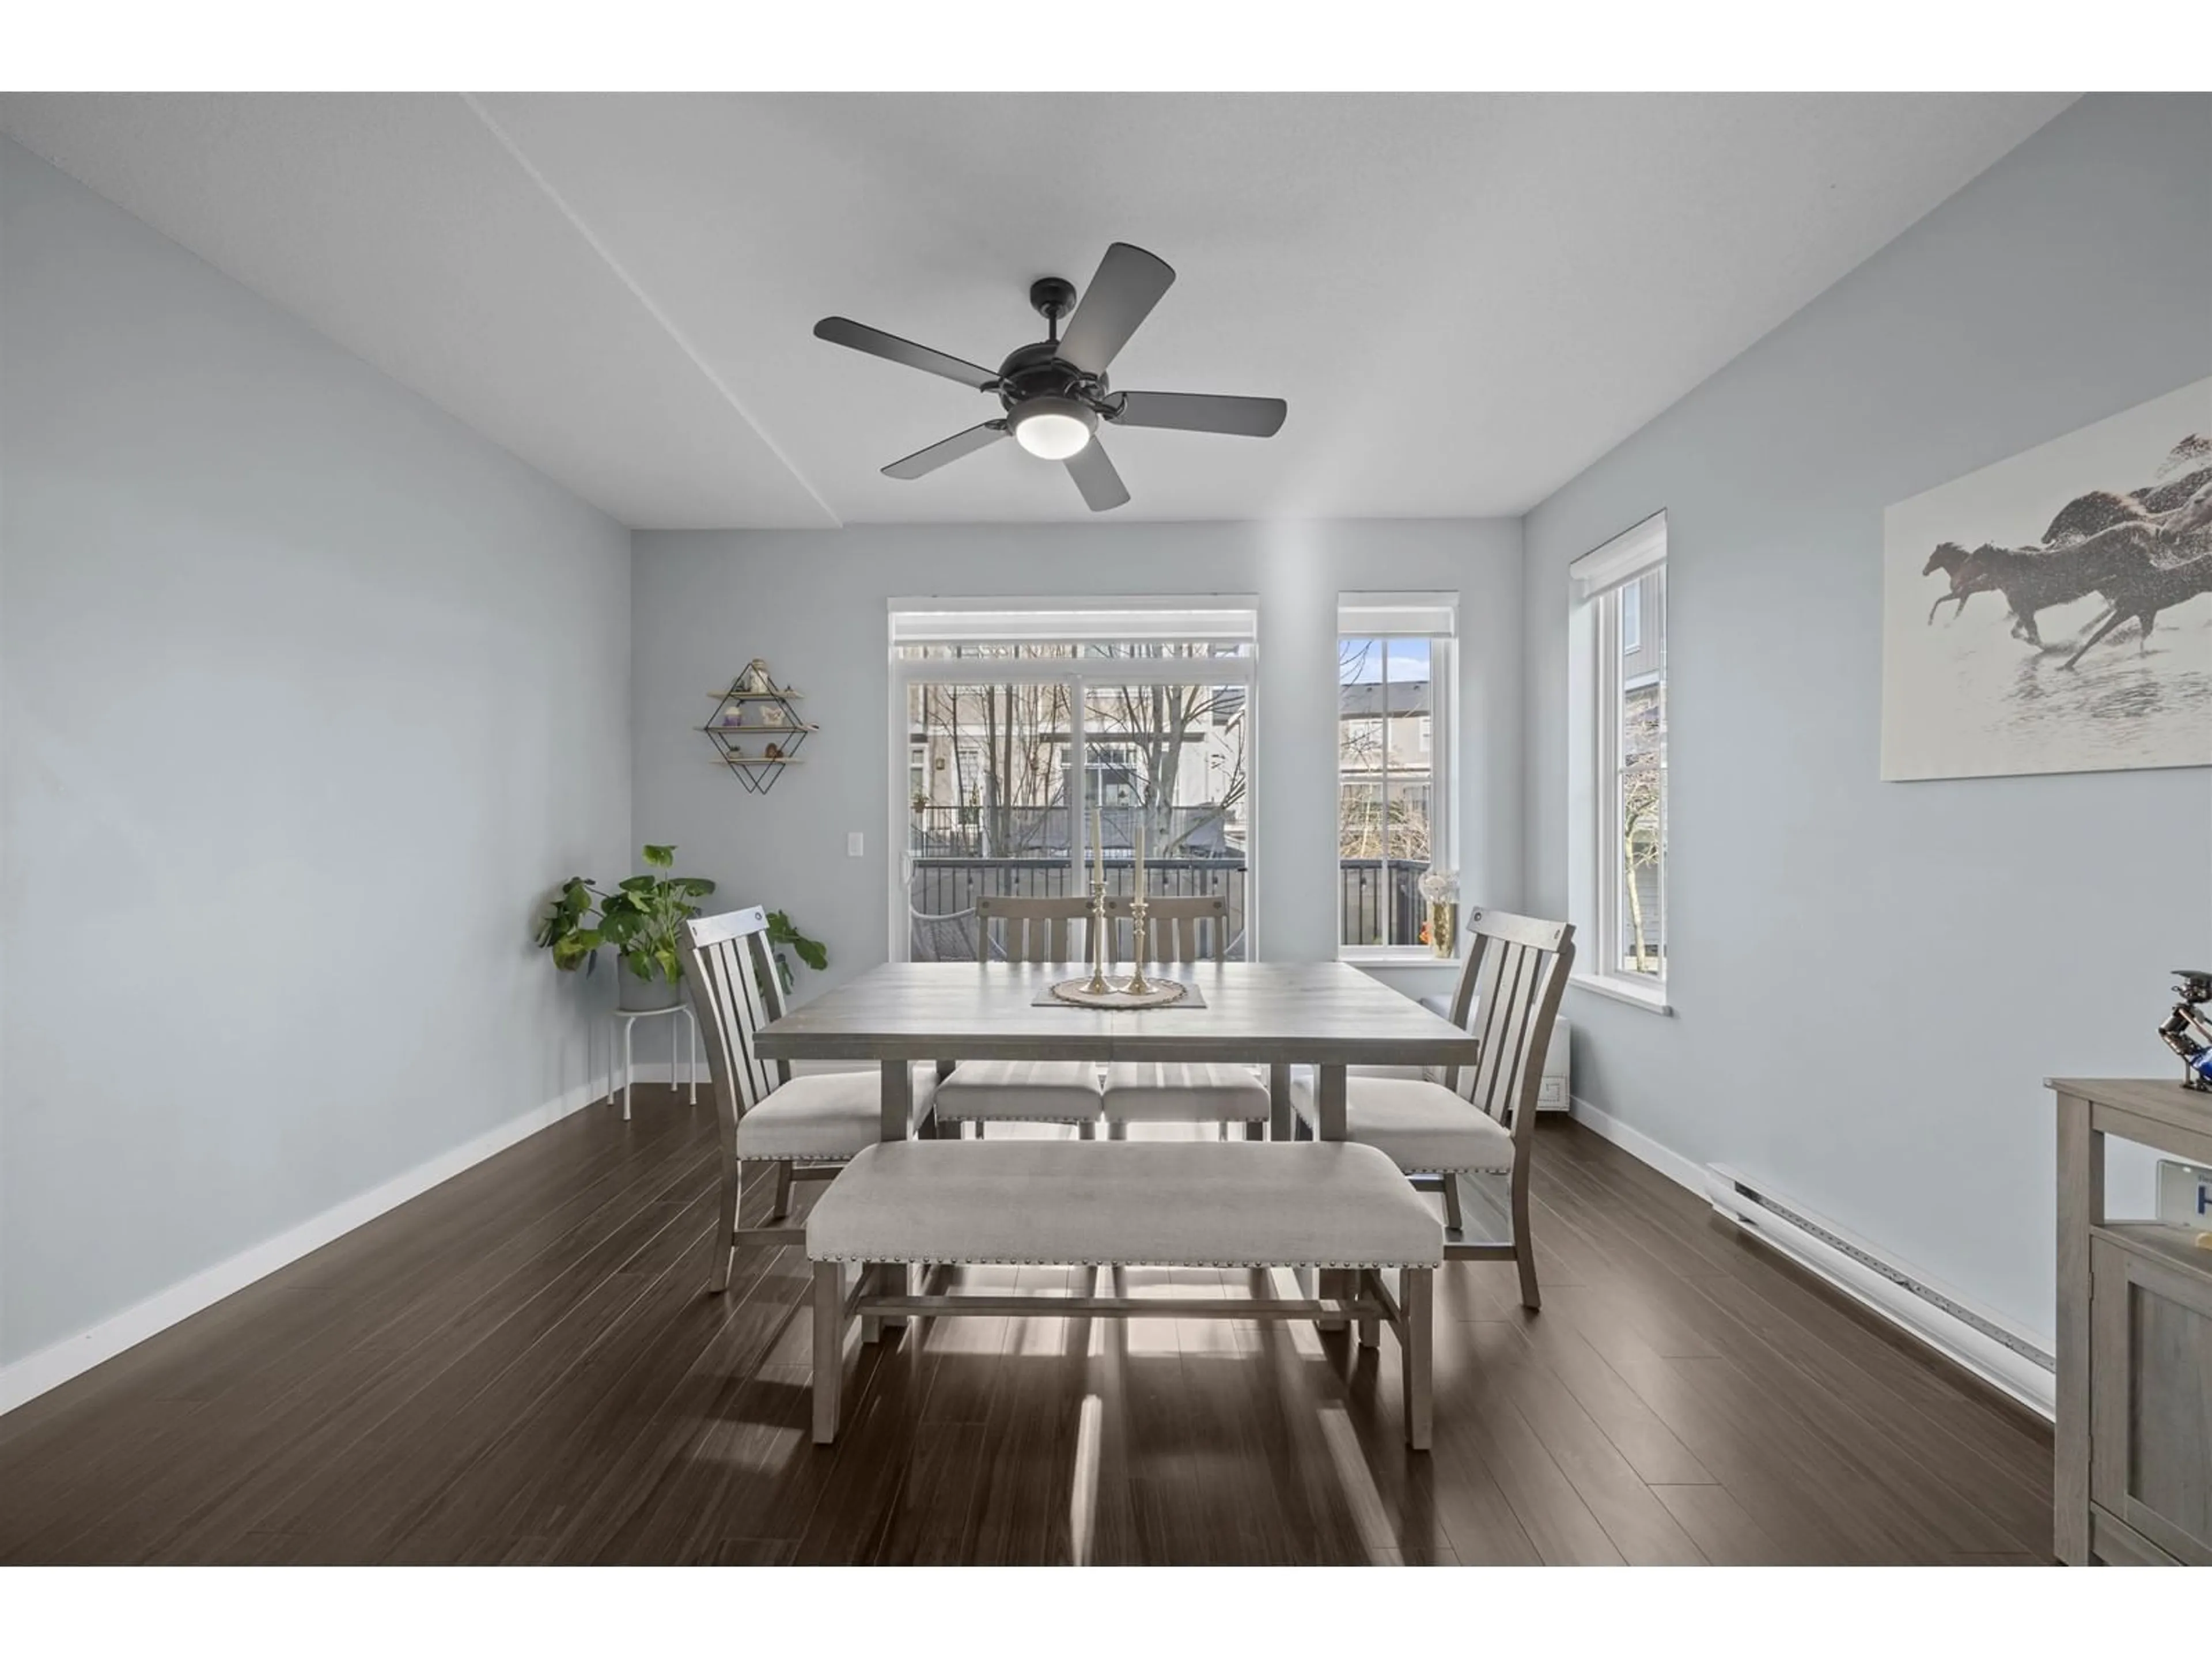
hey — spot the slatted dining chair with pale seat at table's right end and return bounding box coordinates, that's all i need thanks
[1292,909,1575,1307]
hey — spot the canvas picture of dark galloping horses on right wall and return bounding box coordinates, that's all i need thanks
[1883,380,2212,779]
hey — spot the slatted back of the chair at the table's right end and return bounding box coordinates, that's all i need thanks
[1451,909,1575,1166]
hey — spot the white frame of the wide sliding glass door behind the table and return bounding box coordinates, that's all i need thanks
[882,593,1261,962]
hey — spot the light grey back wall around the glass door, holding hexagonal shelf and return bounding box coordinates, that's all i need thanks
[632,526,1522,988]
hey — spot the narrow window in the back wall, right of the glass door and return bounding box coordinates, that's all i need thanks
[1336,593,1458,958]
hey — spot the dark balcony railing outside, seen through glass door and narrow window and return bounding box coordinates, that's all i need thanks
[907,854,1429,962]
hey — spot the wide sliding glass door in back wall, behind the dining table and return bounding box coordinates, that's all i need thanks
[892,600,1256,962]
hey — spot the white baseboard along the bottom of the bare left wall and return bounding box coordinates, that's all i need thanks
[0,1084,610,1414]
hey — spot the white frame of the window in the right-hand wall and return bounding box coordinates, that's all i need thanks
[1566,511,1675,1013]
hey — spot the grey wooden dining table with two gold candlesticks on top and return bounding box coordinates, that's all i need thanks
[754,962,1478,1141]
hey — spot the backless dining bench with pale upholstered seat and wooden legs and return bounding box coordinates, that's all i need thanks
[808,1141,1445,1451]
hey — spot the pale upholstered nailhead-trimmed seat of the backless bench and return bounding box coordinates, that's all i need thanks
[808,1141,1445,1267]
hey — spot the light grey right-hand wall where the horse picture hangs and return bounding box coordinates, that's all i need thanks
[1524,93,2212,1332]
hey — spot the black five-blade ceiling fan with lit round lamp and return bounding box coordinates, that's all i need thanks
[814,241,1290,513]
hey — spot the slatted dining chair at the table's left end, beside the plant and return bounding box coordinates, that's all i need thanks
[684,905,935,1292]
